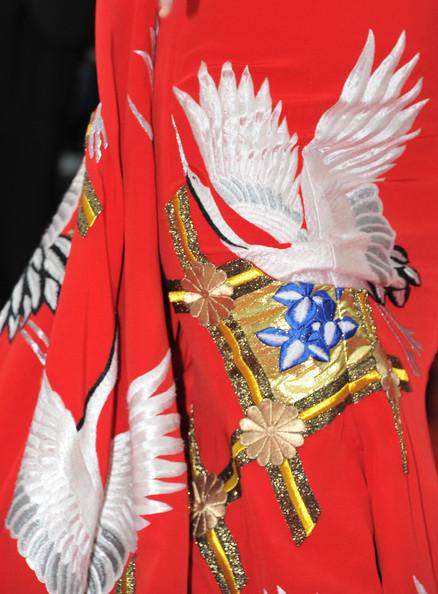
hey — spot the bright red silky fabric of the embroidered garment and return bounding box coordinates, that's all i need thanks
[0,0,438,594]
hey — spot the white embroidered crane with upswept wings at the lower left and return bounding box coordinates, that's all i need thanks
[6,349,185,594]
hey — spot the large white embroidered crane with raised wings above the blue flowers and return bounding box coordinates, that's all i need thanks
[174,32,425,287]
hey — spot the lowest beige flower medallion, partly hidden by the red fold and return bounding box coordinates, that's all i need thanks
[192,474,227,537]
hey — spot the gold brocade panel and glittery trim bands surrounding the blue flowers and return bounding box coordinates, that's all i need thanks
[167,186,408,552]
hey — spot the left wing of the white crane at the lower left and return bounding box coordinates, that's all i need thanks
[6,373,101,594]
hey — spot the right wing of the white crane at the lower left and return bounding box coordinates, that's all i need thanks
[87,352,186,594]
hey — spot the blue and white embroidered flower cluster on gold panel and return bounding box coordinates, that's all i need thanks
[256,283,358,371]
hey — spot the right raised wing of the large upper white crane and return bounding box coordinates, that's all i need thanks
[302,32,426,284]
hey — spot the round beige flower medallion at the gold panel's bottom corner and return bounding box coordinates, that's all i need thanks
[240,398,305,466]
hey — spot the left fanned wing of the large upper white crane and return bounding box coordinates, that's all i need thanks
[174,62,302,242]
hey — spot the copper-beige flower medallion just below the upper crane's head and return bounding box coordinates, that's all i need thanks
[181,262,233,326]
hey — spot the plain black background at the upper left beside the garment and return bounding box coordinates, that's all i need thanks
[0,0,98,308]
